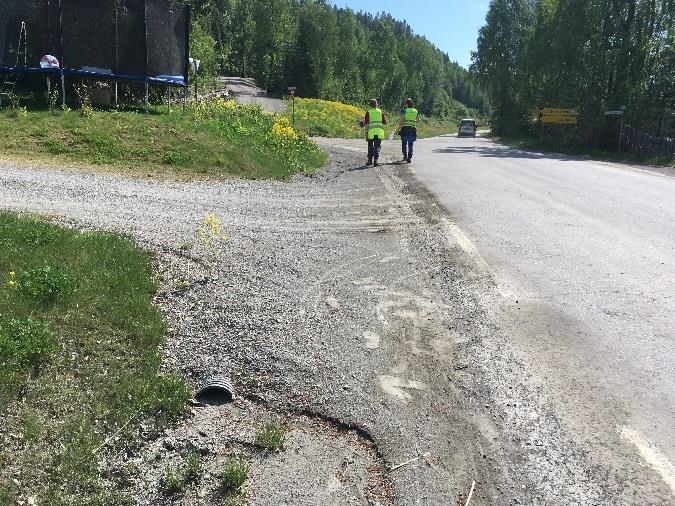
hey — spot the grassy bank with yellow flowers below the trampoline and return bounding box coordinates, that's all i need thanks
[0,101,325,180]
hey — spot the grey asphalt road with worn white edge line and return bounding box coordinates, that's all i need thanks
[411,136,675,504]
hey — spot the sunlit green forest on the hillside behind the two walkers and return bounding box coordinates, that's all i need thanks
[185,0,489,117]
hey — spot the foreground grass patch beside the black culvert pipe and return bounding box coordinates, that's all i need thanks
[0,212,189,505]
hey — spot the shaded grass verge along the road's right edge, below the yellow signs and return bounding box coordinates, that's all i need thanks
[492,136,675,167]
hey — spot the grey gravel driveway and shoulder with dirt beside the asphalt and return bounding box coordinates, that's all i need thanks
[0,141,557,505]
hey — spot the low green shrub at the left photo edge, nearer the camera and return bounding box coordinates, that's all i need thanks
[0,317,59,366]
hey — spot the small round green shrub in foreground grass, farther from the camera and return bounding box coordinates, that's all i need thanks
[16,265,77,305]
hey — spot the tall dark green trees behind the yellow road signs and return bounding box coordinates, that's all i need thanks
[471,0,675,145]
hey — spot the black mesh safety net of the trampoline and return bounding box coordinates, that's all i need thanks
[0,0,190,86]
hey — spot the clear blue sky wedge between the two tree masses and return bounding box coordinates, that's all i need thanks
[332,0,489,68]
